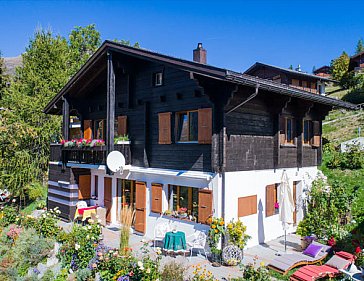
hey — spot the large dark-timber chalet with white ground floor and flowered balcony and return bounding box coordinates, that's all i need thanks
[44,41,355,245]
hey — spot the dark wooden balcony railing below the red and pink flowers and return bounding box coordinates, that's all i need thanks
[50,144,131,165]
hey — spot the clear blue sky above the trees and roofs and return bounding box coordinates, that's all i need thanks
[0,0,364,72]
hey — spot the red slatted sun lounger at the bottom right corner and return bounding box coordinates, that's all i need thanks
[290,252,355,281]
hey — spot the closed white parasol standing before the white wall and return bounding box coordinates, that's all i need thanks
[278,170,295,251]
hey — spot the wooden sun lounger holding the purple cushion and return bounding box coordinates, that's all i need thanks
[268,241,331,275]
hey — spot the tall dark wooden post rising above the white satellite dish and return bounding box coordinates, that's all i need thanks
[106,51,115,154]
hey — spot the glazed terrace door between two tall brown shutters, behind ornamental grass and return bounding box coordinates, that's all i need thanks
[116,179,136,222]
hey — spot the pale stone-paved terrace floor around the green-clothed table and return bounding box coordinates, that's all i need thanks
[103,227,301,280]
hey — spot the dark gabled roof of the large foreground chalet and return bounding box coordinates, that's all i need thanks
[44,41,356,113]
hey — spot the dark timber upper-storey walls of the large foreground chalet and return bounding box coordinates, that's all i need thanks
[46,43,354,172]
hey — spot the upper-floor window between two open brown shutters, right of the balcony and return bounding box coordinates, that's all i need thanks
[176,110,198,142]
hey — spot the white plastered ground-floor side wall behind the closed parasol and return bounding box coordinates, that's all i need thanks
[225,167,317,247]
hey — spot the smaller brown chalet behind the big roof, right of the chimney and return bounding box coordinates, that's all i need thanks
[244,62,335,95]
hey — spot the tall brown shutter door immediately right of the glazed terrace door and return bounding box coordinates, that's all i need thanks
[134,181,147,233]
